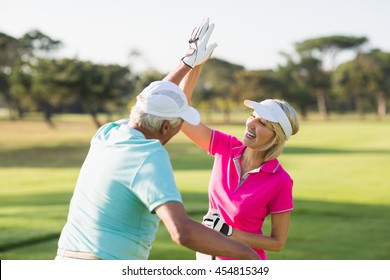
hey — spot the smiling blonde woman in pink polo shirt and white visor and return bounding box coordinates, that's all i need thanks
[180,65,299,259]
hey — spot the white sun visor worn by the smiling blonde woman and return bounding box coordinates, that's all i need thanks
[244,99,292,140]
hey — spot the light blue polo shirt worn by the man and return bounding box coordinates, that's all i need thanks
[58,120,182,260]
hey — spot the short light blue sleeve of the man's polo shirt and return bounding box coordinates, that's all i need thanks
[132,151,183,213]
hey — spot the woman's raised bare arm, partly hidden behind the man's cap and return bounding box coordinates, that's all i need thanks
[180,65,212,151]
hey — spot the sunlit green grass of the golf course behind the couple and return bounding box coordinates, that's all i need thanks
[0,116,390,260]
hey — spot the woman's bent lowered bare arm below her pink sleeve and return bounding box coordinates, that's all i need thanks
[231,212,291,252]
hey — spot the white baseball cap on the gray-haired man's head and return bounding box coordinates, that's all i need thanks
[137,81,200,125]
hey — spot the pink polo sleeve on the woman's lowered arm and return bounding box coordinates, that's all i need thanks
[269,177,294,214]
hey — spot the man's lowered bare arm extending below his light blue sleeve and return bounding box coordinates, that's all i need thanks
[155,202,259,260]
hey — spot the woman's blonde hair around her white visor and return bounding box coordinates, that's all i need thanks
[264,99,299,161]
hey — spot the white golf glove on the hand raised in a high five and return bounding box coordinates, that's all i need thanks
[181,18,217,68]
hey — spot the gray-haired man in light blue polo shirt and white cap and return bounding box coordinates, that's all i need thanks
[56,20,258,260]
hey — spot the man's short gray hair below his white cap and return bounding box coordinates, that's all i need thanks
[129,103,182,132]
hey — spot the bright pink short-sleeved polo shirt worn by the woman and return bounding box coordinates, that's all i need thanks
[209,130,294,259]
